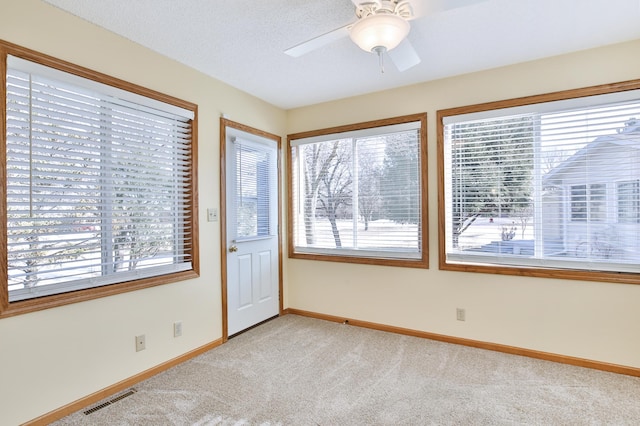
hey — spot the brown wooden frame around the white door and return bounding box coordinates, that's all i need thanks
[220,117,283,343]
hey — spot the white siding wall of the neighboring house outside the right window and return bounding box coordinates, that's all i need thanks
[543,129,640,262]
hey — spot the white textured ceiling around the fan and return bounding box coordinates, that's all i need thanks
[43,0,640,109]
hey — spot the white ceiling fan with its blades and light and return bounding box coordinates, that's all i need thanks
[284,0,485,72]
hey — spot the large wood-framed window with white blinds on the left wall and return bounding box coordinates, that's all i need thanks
[0,44,197,315]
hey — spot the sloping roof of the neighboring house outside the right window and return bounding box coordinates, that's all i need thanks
[543,118,640,184]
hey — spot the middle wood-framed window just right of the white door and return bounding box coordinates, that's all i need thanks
[288,114,428,267]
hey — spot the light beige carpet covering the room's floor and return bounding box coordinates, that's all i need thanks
[54,315,640,426]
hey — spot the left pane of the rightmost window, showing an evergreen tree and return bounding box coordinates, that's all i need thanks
[449,116,534,253]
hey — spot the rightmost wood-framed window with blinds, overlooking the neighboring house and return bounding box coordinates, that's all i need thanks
[438,81,640,283]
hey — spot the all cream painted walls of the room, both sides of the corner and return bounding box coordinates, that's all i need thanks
[0,0,640,425]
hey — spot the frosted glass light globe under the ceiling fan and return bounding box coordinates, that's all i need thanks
[349,14,410,52]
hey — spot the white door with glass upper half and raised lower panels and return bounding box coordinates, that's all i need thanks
[225,127,280,336]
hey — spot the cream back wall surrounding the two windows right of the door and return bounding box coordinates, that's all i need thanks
[287,40,640,367]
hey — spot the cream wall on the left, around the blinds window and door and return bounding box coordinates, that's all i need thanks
[0,0,286,425]
